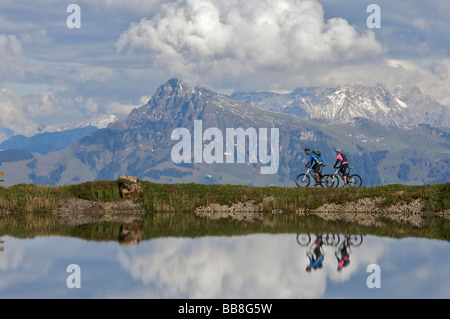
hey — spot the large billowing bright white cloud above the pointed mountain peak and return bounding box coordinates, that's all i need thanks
[116,0,383,84]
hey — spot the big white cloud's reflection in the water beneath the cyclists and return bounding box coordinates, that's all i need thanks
[118,234,383,298]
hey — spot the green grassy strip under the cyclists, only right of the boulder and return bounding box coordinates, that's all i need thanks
[143,183,450,212]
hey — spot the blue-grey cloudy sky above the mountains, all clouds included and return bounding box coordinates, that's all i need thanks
[0,0,450,138]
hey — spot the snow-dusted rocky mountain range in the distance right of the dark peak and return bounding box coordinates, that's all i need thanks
[230,84,450,127]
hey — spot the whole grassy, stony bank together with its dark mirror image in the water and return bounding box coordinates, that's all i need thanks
[0,180,450,240]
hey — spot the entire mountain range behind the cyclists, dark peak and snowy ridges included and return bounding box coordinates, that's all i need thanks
[0,79,450,186]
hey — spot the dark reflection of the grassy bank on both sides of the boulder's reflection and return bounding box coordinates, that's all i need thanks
[0,212,450,241]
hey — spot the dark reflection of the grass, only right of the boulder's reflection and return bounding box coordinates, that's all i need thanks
[142,213,450,240]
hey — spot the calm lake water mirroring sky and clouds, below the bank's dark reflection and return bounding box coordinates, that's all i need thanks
[0,234,450,299]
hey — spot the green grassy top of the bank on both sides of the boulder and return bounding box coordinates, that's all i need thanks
[0,181,450,213]
